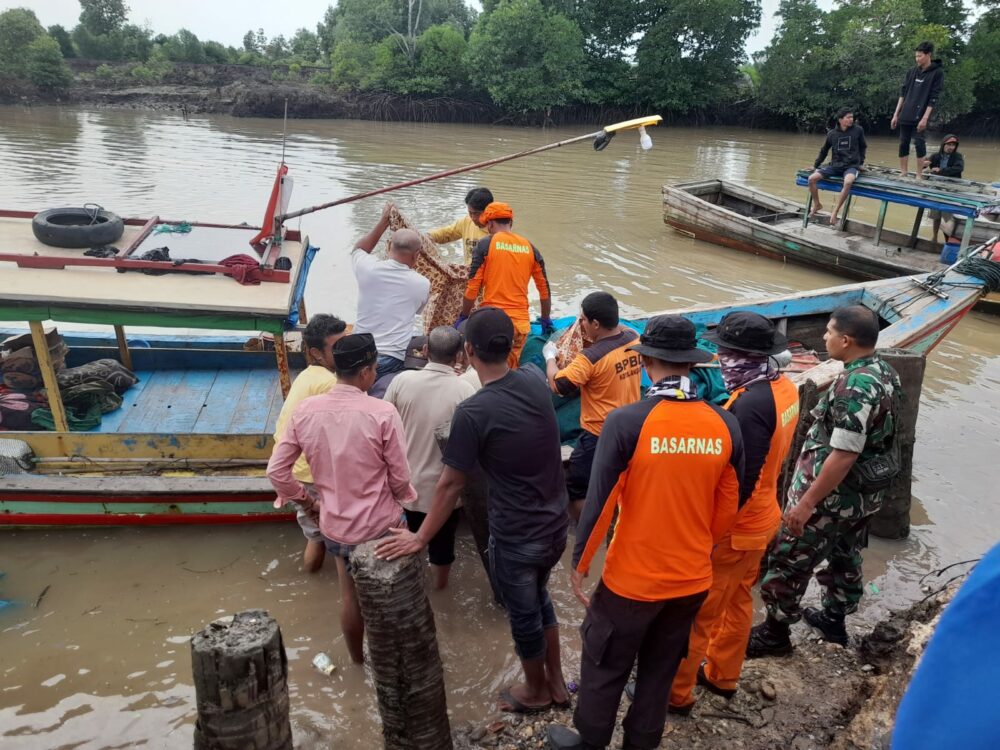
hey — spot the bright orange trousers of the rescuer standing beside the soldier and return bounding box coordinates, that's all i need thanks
[670,534,770,706]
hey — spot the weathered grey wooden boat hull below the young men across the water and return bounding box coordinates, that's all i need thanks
[663,180,1000,312]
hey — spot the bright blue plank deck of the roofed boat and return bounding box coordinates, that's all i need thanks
[92,368,294,435]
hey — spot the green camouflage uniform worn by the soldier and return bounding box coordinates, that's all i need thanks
[761,354,900,623]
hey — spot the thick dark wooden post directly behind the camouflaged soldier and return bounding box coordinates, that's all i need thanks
[869,349,927,539]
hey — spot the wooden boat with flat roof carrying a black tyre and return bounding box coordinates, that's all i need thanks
[0,167,316,526]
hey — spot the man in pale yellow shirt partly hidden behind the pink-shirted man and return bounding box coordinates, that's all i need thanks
[274,315,347,573]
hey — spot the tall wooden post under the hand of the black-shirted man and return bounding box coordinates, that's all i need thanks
[350,542,452,750]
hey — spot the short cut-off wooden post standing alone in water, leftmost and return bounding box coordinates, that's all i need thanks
[191,609,292,750]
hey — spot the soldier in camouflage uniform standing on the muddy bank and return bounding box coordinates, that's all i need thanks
[747,305,900,659]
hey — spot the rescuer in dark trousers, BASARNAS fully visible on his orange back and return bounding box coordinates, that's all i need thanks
[549,315,743,750]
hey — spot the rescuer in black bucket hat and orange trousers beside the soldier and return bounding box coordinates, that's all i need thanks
[668,311,799,715]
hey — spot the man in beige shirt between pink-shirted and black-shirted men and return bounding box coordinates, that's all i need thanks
[384,326,476,589]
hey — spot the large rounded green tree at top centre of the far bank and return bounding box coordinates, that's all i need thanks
[466,0,586,112]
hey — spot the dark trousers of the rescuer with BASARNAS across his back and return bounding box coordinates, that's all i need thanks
[573,581,708,748]
